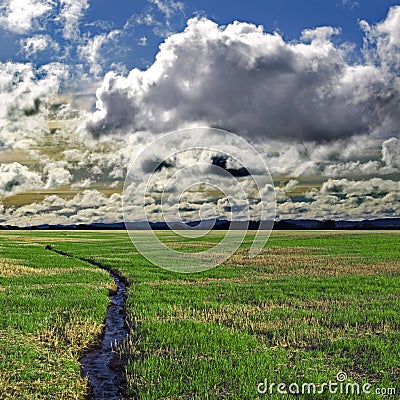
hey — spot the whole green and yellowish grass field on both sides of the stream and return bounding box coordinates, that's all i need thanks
[0,231,400,399]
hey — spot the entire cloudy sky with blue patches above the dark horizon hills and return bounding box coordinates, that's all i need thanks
[0,0,400,226]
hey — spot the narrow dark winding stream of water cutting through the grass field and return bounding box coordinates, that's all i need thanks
[46,246,129,400]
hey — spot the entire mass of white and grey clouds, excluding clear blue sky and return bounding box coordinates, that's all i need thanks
[0,0,400,225]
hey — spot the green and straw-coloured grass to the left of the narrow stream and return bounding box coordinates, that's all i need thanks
[0,232,113,399]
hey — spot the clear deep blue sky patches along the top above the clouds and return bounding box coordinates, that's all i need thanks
[0,0,398,69]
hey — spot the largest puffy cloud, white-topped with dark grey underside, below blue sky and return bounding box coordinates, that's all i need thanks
[86,8,400,141]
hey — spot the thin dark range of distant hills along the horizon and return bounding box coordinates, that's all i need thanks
[0,218,400,230]
